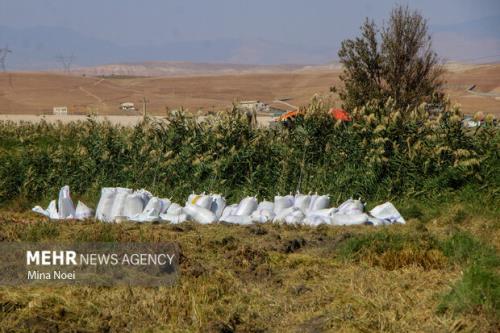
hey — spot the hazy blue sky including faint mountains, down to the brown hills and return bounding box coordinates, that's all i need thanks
[0,0,500,69]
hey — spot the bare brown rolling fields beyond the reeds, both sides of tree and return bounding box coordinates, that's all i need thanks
[0,64,500,116]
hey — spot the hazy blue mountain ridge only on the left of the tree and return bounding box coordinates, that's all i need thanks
[0,26,336,70]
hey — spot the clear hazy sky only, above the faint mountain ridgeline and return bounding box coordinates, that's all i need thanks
[0,0,500,45]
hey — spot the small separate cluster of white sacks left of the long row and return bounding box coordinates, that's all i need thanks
[33,185,94,220]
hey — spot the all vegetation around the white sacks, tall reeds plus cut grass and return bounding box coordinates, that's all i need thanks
[0,98,500,332]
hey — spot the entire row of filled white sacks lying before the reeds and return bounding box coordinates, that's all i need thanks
[33,186,405,226]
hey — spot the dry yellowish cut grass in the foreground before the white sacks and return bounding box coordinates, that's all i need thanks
[0,201,500,332]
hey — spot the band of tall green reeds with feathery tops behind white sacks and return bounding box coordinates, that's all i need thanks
[0,98,500,208]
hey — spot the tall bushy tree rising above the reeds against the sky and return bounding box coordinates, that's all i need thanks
[338,5,443,109]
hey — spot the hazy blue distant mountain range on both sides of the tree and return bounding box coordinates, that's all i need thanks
[0,16,500,71]
